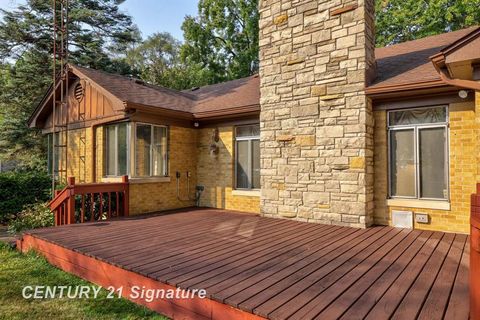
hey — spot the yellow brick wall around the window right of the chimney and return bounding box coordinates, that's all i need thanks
[374,101,480,233]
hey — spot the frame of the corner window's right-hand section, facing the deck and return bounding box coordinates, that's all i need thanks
[132,122,170,179]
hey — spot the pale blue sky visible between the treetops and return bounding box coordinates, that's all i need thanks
[0,0,198,40]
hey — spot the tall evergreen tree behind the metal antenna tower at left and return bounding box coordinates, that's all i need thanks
[0,0,136,168]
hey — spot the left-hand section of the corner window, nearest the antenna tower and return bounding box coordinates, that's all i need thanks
[104,123,130,176]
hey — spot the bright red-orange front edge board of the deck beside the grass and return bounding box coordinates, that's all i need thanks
[17,234,264,320]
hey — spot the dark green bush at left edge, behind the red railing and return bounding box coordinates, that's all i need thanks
[0,170,51,223]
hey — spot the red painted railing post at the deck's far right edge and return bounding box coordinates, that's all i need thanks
[470,184,480,320]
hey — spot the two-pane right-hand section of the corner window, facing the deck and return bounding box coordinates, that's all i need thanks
[135,124,168,177]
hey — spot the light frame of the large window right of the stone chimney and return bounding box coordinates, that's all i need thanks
[387,105,450,202]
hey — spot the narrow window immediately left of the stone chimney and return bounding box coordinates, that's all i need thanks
[235,124,260,189]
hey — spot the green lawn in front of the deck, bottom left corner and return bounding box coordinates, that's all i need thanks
[0,243,167,320]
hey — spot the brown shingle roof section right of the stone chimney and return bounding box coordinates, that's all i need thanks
[369,27,478,88]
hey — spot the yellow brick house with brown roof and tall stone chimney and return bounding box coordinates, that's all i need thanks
[29,1,480,233]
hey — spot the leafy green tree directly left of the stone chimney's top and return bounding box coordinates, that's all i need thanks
[181,0,259,85]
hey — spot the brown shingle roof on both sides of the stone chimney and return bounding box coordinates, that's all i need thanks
[68,27,478,115]
